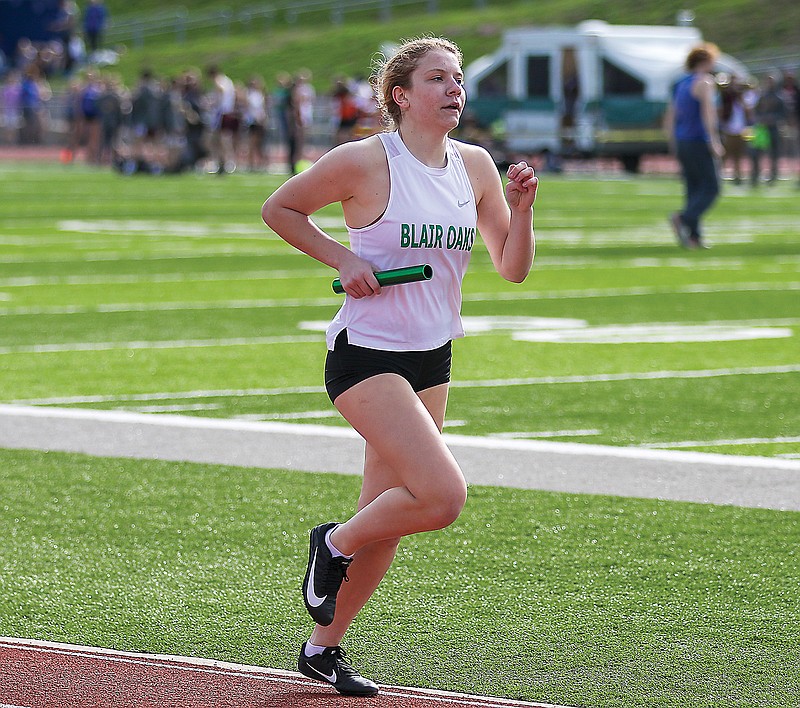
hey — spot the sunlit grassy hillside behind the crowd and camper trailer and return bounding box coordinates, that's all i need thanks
[98,0,800,90]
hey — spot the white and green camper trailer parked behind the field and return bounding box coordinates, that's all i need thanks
[465,20,748,171]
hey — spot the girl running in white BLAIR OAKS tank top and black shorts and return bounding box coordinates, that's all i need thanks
[262,38,538,695]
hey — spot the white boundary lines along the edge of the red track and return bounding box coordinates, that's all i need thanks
[0,637,569,708]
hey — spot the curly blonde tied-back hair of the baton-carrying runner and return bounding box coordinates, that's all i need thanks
[370,37,464,130]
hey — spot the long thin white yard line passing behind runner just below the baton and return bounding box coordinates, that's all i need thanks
[0,282,800,315]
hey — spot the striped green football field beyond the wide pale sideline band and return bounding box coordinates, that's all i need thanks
[0,161,800,456]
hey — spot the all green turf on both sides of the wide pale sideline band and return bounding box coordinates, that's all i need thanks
[0,164,800,708]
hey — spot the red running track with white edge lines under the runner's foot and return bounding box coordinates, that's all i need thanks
[0,638,563,708]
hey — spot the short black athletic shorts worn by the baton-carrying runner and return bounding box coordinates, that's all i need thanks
[325,329,452,402]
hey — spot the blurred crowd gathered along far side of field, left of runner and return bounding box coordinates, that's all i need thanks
[0,50,379,174]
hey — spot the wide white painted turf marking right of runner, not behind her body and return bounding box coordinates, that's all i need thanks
[511,324,794,344]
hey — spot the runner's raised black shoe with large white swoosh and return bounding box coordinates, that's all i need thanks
[303,522,352,627]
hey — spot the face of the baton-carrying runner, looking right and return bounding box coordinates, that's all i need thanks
[404,49,467,130]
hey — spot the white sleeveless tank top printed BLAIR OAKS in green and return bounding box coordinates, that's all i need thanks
[326,132,477,351]
